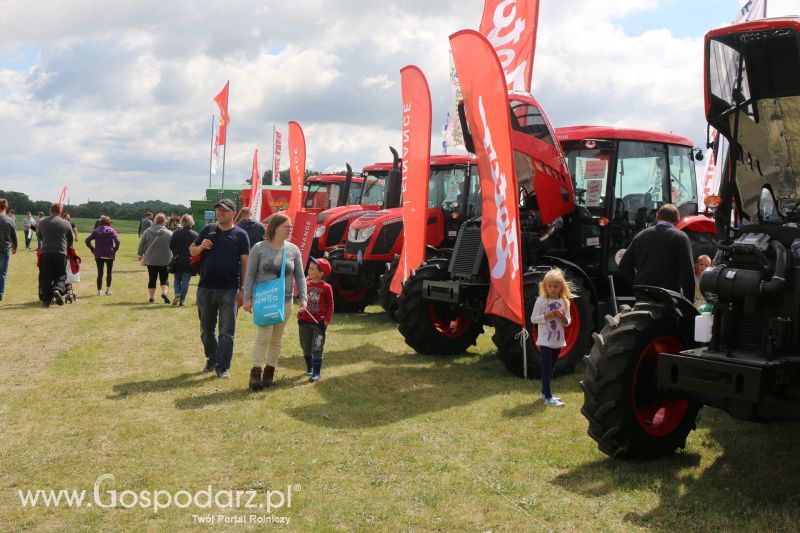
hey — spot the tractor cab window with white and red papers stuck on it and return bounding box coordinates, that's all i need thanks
[566,145,614,215]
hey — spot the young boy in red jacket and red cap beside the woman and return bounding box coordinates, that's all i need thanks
[297,257,333,383]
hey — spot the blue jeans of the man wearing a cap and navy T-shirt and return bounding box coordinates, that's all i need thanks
[197,287,239,372]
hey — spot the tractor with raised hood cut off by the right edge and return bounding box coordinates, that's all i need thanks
[581,18,800,459]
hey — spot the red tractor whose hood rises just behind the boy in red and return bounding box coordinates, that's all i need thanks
[311,163,392,257]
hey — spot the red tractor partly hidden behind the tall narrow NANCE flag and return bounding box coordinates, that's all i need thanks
[328,154,480,315]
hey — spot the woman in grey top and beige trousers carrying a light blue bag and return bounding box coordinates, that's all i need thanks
[244,214,307,391]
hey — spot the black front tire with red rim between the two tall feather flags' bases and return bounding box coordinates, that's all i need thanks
[397,259,483,355]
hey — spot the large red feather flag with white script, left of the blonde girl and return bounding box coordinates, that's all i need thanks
[450,30,525,324]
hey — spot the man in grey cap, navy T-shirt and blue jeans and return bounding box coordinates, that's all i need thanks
[189,198,250,378]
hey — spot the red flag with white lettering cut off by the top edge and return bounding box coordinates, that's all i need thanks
[480,0,539,93]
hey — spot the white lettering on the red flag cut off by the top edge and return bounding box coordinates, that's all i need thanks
[486,0,528,91]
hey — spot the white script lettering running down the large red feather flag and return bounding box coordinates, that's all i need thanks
[478,96,519,279]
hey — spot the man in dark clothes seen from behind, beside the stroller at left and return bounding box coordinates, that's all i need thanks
[36,204,73,307]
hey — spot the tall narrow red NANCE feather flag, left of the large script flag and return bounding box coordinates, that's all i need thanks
[389,65,431,294]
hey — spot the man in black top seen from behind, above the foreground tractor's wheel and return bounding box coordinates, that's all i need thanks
[619,204,694,300]
